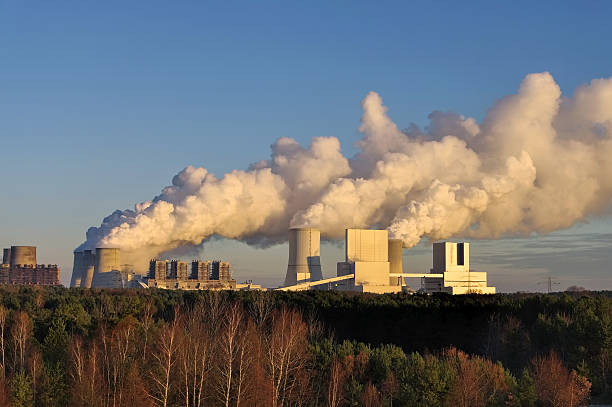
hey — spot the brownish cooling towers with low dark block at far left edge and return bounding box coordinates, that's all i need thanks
[0,246,60,285]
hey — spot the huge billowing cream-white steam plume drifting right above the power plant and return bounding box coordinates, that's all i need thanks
[82,73,612,262]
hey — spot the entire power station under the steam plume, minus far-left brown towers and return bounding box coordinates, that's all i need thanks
[67,228,495,294]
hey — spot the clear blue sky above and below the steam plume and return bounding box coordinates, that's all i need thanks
[0,0,612,290]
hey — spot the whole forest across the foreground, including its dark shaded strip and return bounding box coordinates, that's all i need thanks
[0,287,612,407]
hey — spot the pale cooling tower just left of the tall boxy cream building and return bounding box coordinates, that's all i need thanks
[285,228,323,286]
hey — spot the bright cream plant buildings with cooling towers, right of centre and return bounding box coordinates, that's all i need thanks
[279,228,495,294]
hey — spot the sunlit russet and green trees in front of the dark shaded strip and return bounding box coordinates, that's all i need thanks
[0,291,591,407]
